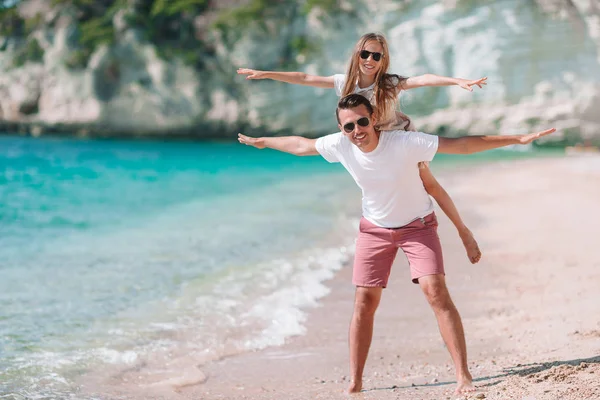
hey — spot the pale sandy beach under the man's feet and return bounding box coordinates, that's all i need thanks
[86,155,600,400]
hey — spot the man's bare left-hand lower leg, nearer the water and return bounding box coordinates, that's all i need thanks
[348,287,382,393]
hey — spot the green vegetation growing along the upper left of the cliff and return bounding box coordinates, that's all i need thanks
[0,0,342,70]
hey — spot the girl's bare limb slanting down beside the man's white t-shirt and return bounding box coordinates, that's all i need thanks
[419,163,481,264]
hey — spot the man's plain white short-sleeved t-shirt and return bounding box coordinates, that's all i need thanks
[316,131,438,228]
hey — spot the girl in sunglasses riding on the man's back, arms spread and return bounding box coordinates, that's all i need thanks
[237,33,487,264]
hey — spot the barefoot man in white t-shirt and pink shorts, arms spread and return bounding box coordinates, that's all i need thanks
[238,94,555,394]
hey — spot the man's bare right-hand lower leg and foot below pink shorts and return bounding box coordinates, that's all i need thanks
[419,275,476,394]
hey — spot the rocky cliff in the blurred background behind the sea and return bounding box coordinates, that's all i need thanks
[0,0,600,141]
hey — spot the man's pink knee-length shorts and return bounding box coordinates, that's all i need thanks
[352,213,444,287]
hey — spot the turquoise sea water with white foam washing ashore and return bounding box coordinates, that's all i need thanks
[0,136,552,398]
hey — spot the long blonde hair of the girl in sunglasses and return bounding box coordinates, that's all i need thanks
[342,33,407,130]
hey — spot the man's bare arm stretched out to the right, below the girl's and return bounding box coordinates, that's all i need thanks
[438,128,556,154]
